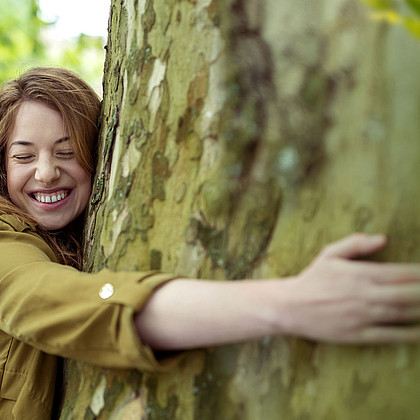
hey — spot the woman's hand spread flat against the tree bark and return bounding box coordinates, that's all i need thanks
[279,234,420,344]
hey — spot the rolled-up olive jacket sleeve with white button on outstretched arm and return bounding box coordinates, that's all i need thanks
[0,221,180,371]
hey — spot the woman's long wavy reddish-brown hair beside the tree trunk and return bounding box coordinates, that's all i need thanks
[0,67,101,268]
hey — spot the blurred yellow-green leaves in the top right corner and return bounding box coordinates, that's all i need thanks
[361,0,420,38]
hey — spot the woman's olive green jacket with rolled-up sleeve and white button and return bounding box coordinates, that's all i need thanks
[0,215,177,420]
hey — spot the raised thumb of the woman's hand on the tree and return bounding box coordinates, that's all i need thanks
[321,233,387,258]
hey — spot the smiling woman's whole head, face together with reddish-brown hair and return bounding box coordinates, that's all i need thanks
[0,67,100,266]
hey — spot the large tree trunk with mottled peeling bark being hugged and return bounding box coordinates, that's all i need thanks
[61,0,420,420]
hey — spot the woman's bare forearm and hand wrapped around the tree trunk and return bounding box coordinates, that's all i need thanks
[135,234,420,350]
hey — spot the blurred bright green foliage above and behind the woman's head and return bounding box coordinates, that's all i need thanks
[0,0,105,93]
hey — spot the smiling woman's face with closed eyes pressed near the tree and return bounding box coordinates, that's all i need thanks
[6,101,91,230]
